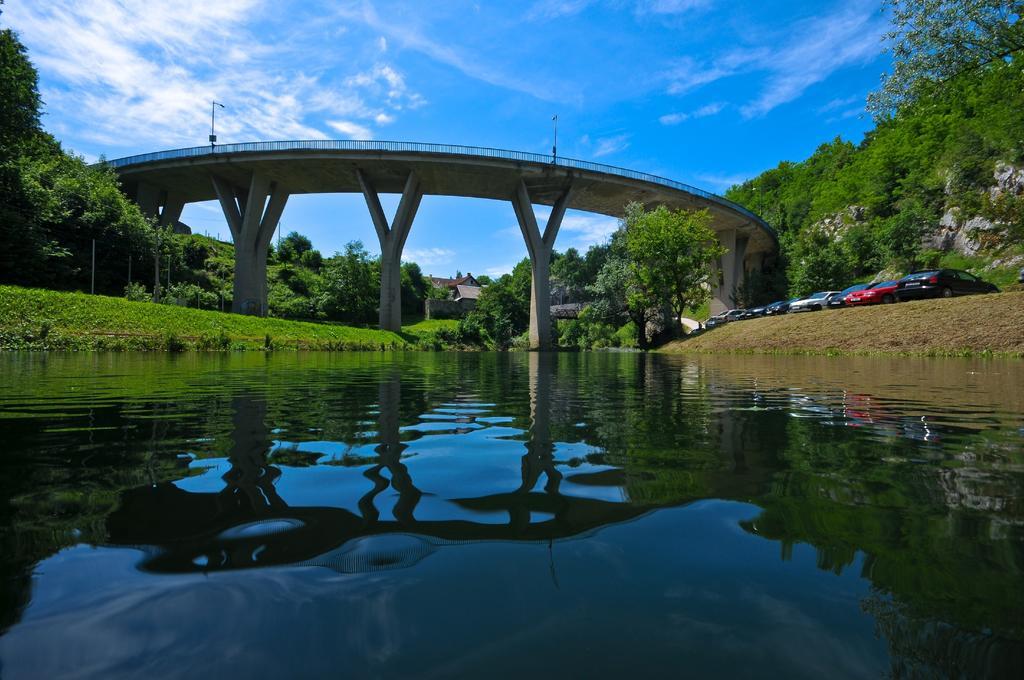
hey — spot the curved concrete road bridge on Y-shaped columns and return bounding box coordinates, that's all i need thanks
[109,140,778,348]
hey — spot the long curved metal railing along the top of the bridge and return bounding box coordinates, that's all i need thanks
[106,139,774,235]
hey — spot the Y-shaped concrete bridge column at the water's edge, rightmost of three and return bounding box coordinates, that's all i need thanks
[512,179,572,349]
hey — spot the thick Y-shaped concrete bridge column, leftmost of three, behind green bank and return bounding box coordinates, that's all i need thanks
[213,172,288,316]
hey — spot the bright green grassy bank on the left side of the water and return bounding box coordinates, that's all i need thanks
[0,286,451,350]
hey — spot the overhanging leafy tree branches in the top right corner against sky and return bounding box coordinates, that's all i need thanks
[867,0,1024,118]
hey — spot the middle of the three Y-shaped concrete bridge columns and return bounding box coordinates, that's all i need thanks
[355,170,423,333]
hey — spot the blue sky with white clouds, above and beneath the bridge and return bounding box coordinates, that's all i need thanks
[6,0,888,274]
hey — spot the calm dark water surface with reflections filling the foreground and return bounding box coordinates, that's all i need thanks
[0,353,1024,678]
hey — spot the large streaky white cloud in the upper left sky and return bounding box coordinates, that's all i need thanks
[4,0,422,146]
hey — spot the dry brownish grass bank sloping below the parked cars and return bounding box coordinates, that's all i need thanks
[663,292,1024,356]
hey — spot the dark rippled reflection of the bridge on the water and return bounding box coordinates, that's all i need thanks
[108,353,651,571]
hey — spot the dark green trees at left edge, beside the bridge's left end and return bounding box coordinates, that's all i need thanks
[0,19,154,295]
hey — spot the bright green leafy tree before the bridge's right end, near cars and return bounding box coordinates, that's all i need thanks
[626,204,726,335]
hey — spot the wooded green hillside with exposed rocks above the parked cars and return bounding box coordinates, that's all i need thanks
[726,58,1024,306]
